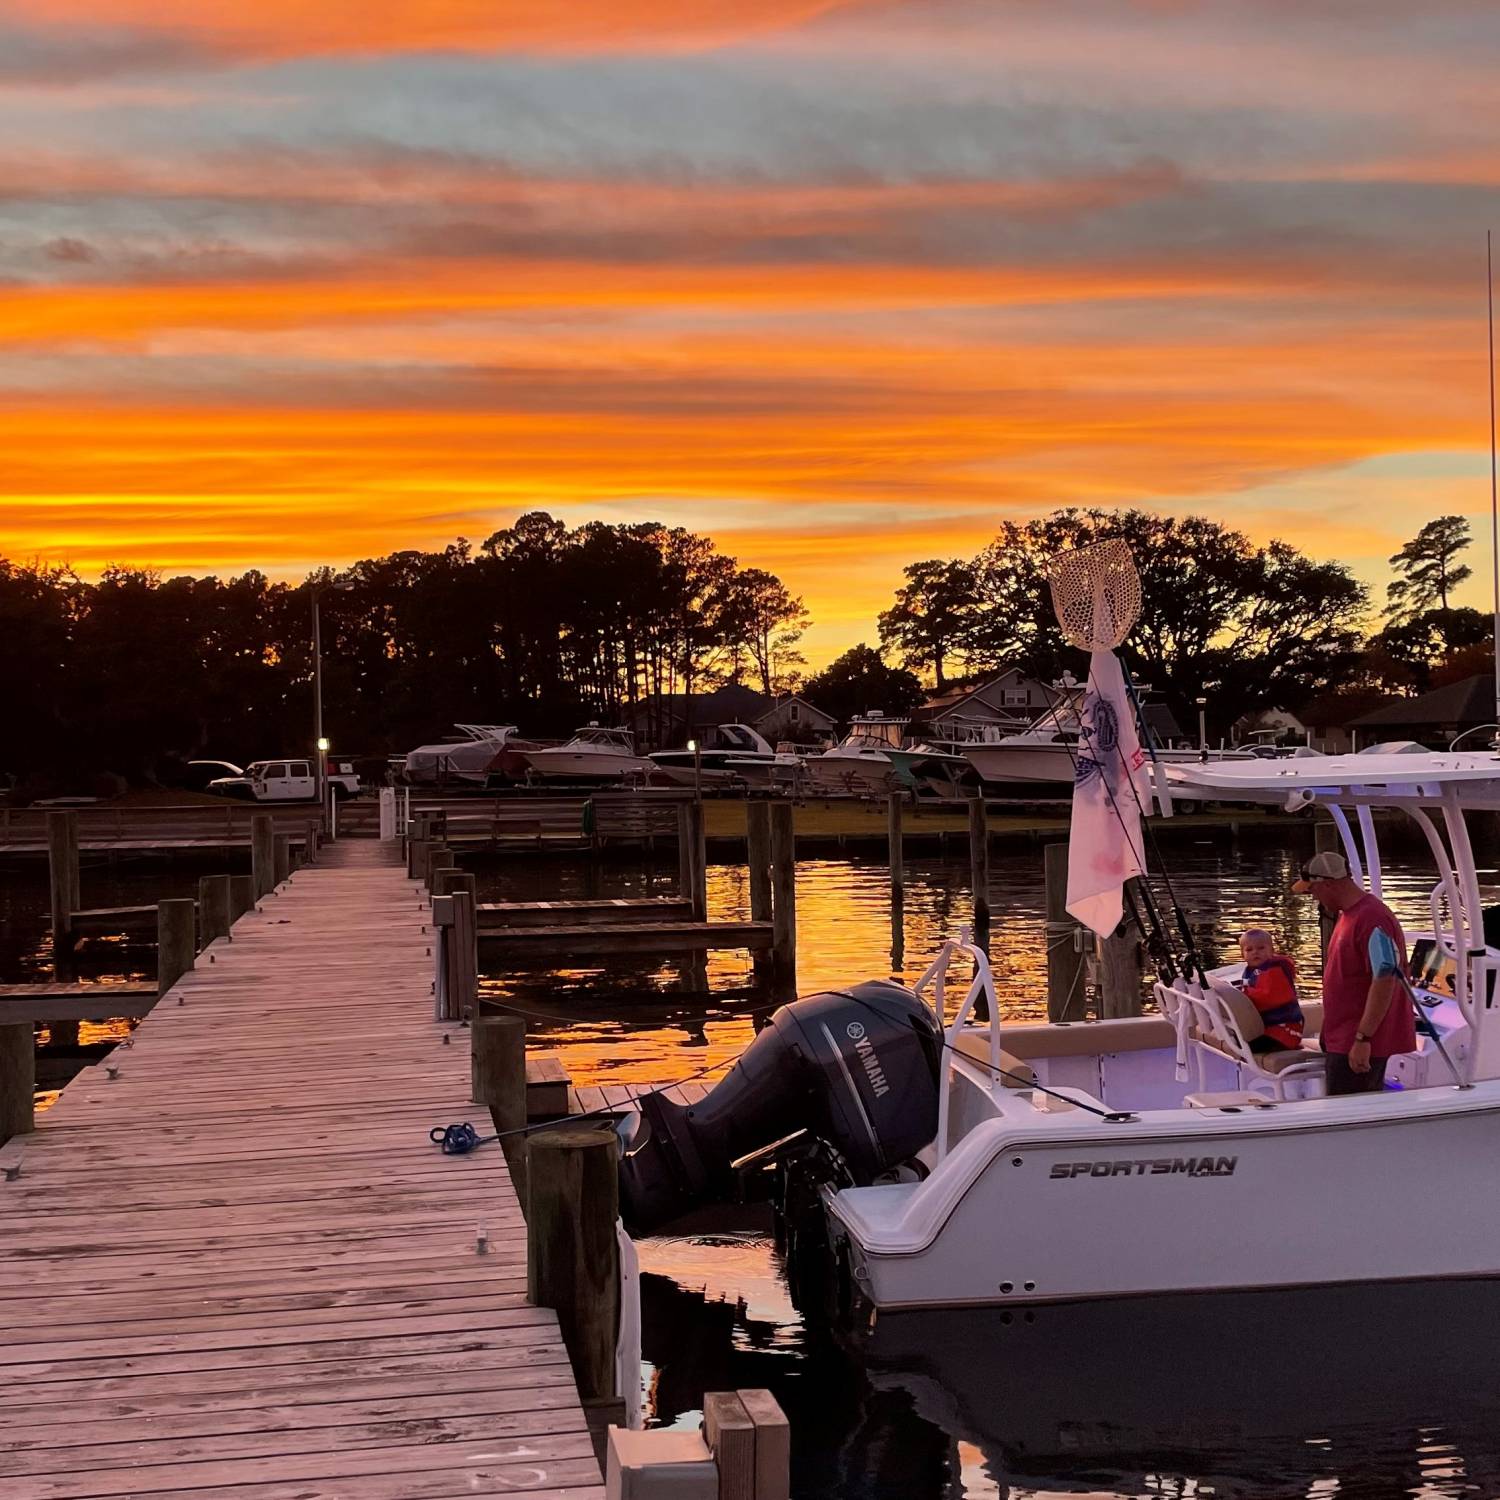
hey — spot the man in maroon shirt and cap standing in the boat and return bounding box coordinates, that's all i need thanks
[1292,851,1416,1094]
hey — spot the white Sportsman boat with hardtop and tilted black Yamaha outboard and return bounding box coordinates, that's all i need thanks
[621,753,1500,1308]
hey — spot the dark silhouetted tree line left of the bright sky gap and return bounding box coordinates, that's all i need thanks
[0,513,807,782]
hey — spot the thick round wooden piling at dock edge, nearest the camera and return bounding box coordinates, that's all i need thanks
[527,1125,620,1401]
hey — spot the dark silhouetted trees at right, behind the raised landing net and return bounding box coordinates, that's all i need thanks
[879,509,1490,729]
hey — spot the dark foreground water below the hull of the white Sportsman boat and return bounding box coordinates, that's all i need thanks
[642,1235,1500,1500]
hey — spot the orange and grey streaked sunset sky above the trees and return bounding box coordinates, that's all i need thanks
[0,0,1500,663]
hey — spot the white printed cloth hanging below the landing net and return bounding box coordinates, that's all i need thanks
[1068,651,1151,938]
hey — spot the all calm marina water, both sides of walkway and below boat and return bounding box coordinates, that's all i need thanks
[11,825,1500,1500]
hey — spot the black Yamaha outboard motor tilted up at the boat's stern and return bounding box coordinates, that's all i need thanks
[620,980,942,1233]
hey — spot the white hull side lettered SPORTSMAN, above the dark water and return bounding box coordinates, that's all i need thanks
[825,1082,1500,1310]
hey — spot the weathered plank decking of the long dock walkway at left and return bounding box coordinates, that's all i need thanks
[0,842,603,1500]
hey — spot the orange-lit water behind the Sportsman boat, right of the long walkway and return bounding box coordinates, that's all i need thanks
[477,821,1476,1083]
